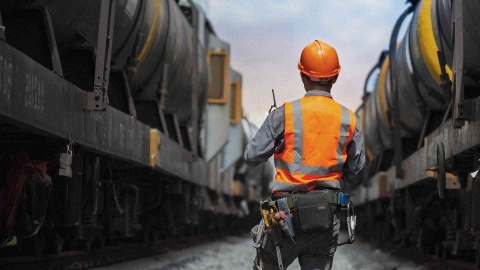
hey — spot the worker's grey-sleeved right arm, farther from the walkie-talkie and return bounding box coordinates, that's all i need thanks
[343,118,365,184]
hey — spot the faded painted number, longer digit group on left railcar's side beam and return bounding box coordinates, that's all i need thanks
[24,74,45,114]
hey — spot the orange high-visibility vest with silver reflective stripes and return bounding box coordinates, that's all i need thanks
[273,96,356,192]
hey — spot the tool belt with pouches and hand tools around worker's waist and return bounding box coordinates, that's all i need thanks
[252,189,356,270]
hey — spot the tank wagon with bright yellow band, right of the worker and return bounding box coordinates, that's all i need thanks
[350,0,480,266]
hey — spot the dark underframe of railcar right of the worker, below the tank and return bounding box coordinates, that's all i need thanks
[351,84,480,266]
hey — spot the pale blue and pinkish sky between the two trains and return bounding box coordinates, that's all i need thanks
[200,0,407,126]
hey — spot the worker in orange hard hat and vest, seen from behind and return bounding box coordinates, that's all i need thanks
[244,40,365,270]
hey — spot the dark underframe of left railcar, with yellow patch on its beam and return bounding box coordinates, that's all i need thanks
[0,31,248,254]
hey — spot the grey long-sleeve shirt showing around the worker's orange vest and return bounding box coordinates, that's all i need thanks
[244,90,365,188]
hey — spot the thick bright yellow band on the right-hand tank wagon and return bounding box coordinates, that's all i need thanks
[417,0,452,84]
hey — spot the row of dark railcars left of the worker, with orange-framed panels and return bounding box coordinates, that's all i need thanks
[0,0,273,255]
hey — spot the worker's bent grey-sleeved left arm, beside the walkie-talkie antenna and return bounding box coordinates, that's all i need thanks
[243,106,285,166]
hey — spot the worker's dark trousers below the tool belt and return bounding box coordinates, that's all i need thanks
[252,192,340,270]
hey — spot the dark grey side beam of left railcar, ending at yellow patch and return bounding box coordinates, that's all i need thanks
[0,41,150,165]
